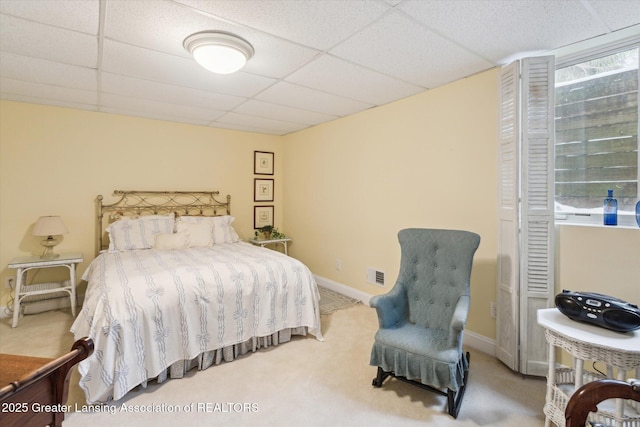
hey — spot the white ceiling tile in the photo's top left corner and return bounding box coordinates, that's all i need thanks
[0,0,100,35]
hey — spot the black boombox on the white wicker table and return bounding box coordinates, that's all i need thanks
[556,290,640,332]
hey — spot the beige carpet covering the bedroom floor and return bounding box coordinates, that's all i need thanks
[0,304,545,427]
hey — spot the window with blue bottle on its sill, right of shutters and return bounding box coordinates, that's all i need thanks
[555,44,640,225]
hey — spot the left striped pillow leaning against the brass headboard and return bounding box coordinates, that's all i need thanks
[107,214,175,252]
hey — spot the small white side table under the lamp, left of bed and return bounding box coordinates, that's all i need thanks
[8,252,83,328]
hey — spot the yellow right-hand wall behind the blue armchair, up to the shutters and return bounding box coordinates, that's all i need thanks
[284,70,498,338]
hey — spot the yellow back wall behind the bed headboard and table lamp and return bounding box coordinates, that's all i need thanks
[0,101,284,306]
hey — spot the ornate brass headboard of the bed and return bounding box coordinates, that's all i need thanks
[96,190,231,255]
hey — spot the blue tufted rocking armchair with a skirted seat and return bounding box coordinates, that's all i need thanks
[369,228,480,418]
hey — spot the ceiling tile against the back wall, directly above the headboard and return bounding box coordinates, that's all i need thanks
[100,94,224,125]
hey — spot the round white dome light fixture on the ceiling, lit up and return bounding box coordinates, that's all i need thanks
[183,31,254,74]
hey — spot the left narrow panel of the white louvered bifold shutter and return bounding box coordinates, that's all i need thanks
[496,61,520,371]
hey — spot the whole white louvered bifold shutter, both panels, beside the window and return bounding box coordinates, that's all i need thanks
[496,56,555,376]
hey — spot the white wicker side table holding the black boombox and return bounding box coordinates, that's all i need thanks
[538,308,640,427]
